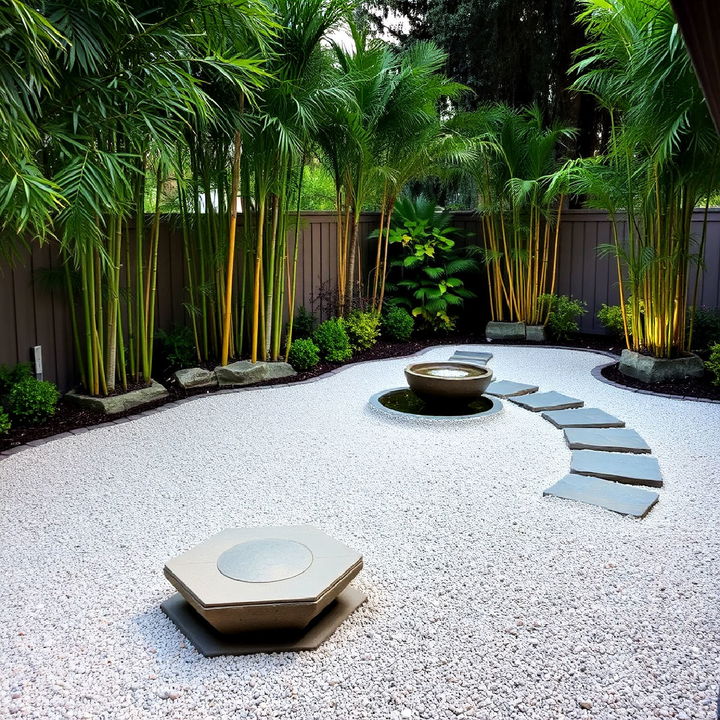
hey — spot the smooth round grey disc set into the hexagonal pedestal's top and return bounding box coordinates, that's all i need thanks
[217,538,313,582]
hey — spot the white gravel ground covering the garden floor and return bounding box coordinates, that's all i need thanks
[0,346,720,720]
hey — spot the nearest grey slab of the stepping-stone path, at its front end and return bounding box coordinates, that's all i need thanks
[543,473,659,518]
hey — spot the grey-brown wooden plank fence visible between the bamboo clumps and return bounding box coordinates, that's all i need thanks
[0,209,720,390]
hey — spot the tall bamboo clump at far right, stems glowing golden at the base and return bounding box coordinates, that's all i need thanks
[575,0,720,357]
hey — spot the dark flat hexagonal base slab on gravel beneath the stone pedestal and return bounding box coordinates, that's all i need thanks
[160,587,367,657]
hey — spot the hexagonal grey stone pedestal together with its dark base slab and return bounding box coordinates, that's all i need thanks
[161,525,365,654]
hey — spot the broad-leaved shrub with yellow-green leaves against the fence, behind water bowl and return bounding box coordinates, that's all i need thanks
[388,197,477,331]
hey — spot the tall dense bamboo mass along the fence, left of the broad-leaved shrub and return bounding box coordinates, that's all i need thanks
[0,0,460,394]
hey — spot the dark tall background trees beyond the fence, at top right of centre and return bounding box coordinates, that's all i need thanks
[365,0,609,156]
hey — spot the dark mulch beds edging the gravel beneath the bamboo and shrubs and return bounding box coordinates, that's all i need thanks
[0,334,720,451]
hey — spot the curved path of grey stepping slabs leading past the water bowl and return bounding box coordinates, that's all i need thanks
[450,350,663,518]
